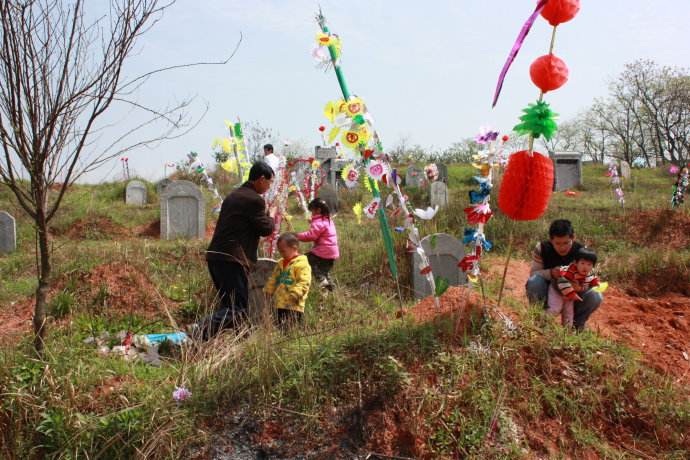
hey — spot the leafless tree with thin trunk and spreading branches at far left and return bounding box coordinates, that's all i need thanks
[0,0,241,352]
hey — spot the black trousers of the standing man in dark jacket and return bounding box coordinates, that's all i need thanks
[202,260,249,340]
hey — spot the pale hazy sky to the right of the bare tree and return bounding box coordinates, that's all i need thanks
[85,0,690,182]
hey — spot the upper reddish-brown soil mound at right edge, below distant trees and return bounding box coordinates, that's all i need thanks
[620,209,690,249]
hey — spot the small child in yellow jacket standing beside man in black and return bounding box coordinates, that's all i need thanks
[264,233,311,327]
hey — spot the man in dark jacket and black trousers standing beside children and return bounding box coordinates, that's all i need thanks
[204,161,274,338]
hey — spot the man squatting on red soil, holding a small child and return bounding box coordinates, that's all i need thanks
[526,219,603,330]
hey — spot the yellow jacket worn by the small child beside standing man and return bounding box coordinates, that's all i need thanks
[264,255,311,312]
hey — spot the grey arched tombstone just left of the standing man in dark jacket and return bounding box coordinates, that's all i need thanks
[161,180,206,240]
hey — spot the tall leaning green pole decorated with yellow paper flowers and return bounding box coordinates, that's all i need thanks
[314,10,442,306]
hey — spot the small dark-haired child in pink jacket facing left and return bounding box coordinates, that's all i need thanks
[297,198,340,291]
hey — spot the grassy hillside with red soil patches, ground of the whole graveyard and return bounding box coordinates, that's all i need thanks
[0,165,690,459]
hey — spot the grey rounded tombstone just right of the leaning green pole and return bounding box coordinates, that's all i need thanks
[412,233,467,299]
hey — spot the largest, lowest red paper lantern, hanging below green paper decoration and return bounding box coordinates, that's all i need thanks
[498,150,553,220]
